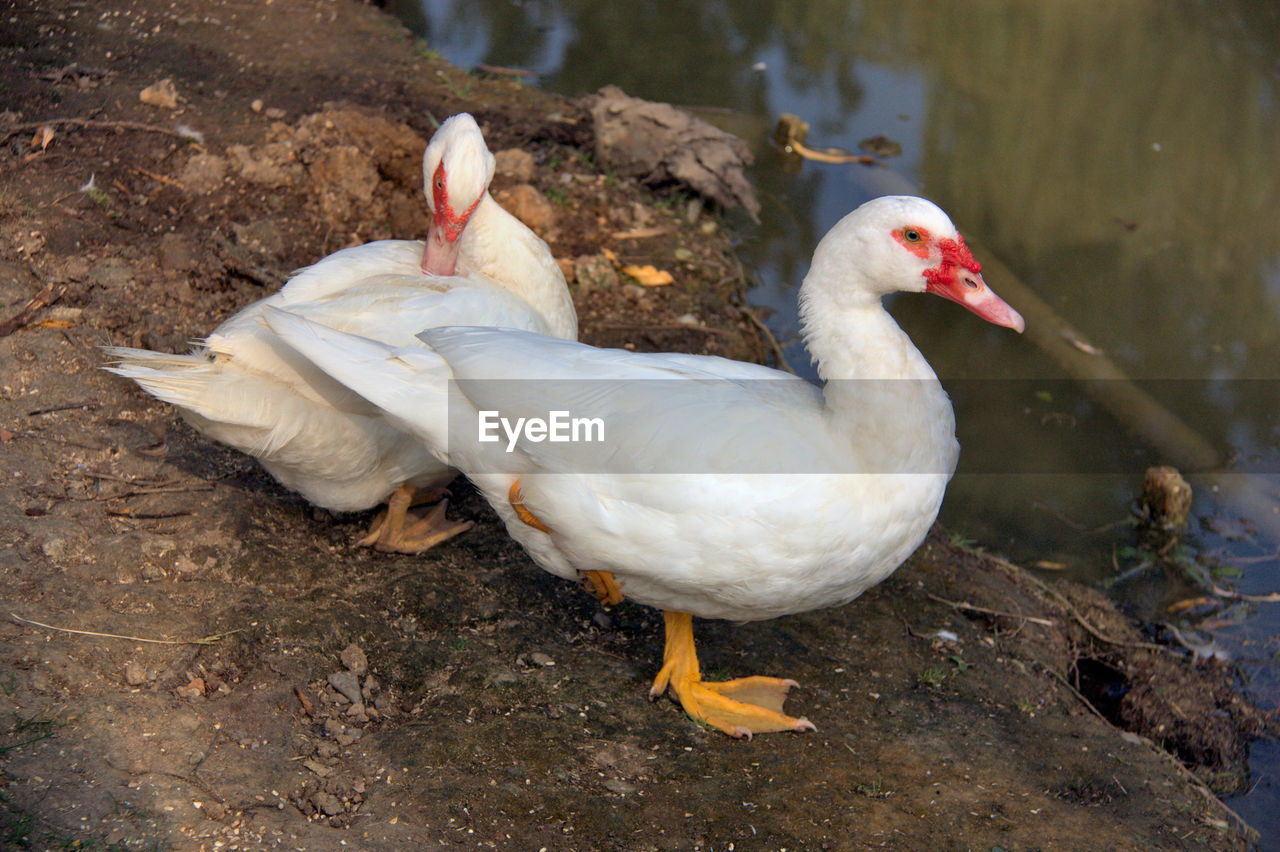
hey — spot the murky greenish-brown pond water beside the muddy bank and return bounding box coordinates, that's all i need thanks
[393,0,1280,837]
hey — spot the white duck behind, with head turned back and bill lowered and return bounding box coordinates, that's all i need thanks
[106,114,577,553]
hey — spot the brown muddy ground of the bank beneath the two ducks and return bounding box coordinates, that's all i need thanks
[0,0,1265,849]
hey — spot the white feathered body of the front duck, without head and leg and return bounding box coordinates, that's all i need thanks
[269,312,957,620]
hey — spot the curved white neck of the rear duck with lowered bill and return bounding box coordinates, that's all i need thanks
[458,192,577,340]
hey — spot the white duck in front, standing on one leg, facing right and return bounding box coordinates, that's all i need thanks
[259,197,1023,736]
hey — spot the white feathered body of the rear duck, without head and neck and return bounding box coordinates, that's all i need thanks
[108,241,576,510]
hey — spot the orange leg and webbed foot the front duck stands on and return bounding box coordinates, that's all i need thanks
[649,611,817,737]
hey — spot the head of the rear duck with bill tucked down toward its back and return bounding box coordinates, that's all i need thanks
[422,113,494,275]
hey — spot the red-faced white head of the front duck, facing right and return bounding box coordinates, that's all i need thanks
[800,196,1025,331]
